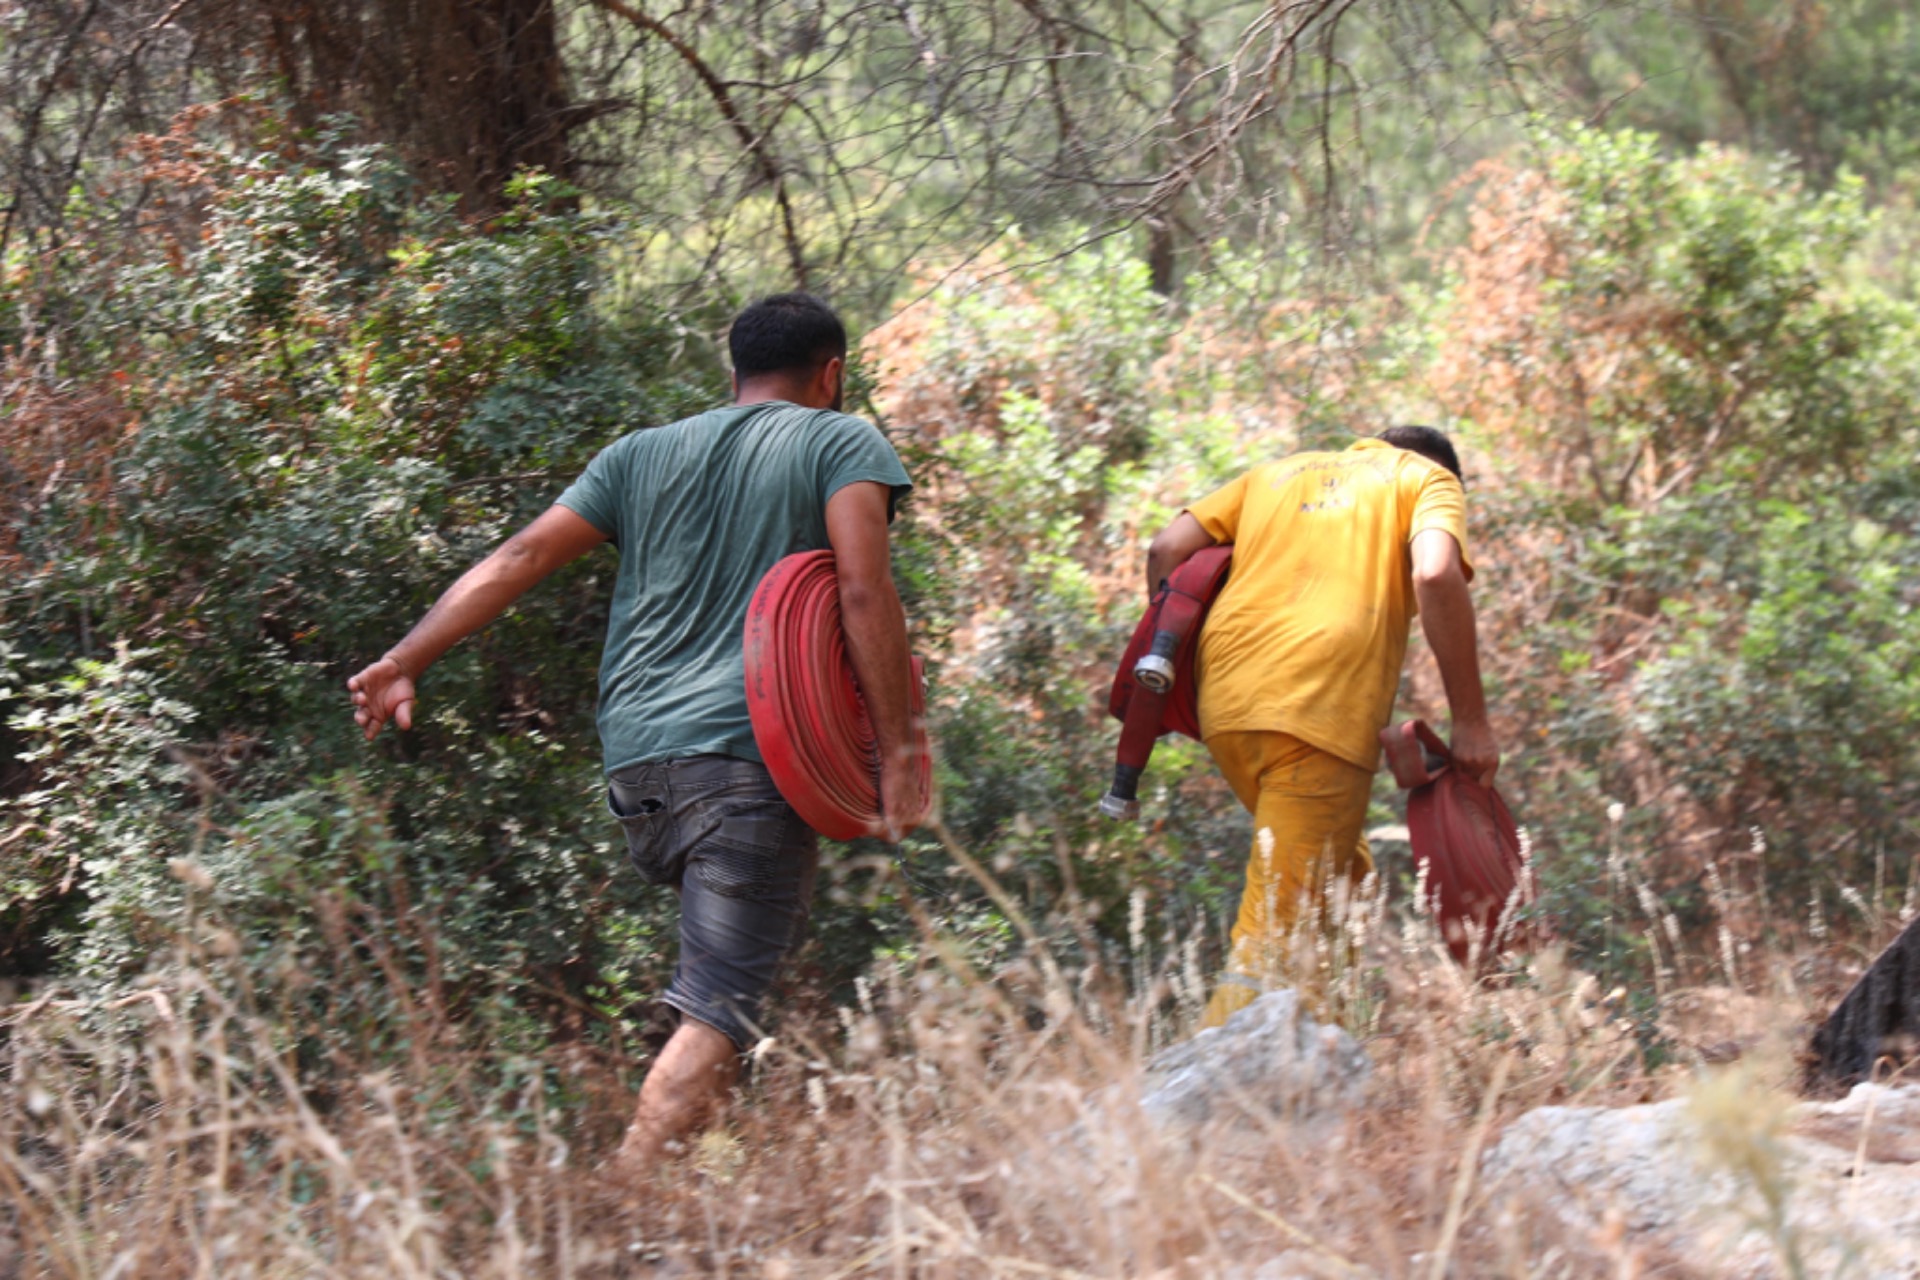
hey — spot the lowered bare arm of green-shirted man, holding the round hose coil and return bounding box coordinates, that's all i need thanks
[828,480,924,841]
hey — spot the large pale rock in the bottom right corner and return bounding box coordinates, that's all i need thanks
[1482,1084,1920,1280]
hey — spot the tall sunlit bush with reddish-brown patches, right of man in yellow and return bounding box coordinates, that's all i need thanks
[1436,132,1920,959]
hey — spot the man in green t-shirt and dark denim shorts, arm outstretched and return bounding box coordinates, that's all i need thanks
[348,294,920,1174]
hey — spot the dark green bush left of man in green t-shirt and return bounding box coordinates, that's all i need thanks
[0,119,720,1043]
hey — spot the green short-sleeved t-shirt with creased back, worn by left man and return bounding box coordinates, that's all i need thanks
[557,401,912,773]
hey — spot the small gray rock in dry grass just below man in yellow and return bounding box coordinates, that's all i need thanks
[1140,990,1373,1128]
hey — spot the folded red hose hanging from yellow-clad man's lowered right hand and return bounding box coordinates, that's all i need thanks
[1380,720,1538,963]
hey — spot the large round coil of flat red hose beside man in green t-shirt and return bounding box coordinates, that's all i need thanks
[745,551,933,841]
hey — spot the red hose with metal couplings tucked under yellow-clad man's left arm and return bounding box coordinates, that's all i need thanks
[1100,543,1233,821]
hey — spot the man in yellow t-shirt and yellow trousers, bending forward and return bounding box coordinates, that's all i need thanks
[1146,426,1500,1027]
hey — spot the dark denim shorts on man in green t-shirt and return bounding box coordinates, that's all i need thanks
[607,756,820,1050]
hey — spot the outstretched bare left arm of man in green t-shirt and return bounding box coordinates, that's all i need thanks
[348,507,607,741]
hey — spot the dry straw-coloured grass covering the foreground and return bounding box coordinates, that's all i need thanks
[0,821,1889,1280]
